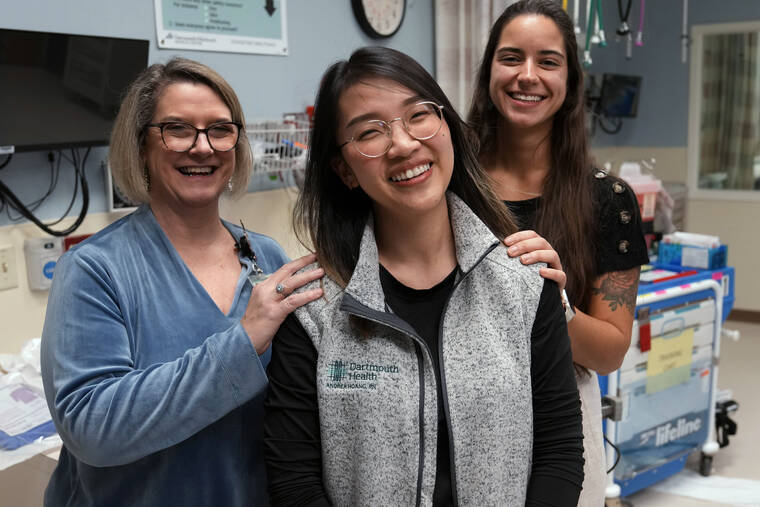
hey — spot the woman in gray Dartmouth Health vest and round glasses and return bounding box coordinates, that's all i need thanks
[265,48,583,506]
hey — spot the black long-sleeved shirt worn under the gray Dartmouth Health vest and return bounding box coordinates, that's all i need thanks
[264,266,583,506]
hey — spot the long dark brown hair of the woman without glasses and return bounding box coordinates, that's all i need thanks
[468,0,594,310]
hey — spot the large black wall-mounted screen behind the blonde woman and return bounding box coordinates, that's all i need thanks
[0,29,149,151]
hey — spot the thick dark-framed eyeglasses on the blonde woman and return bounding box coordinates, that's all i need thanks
[145,121,243,153]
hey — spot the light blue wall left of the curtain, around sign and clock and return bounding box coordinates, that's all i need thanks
[0,0,435,225]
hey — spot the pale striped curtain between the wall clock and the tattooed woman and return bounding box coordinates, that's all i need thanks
[435,0,517,117]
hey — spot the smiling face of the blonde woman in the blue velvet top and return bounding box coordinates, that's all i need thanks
[143,82,235,211]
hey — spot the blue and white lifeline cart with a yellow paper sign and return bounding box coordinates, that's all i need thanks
[599,267,734,498]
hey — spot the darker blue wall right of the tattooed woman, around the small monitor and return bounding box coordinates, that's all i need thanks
[588,0,760,147]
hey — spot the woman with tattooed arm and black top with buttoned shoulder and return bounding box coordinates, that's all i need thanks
[469,0,648,506]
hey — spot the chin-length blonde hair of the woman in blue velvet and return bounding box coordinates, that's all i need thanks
[108,58,253,204]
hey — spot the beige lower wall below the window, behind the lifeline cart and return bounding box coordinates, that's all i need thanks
[594,147,760,312]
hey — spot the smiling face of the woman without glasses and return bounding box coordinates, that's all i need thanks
[489,14,567,134]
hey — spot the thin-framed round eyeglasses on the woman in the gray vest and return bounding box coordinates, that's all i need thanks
[338,101,443,158]
